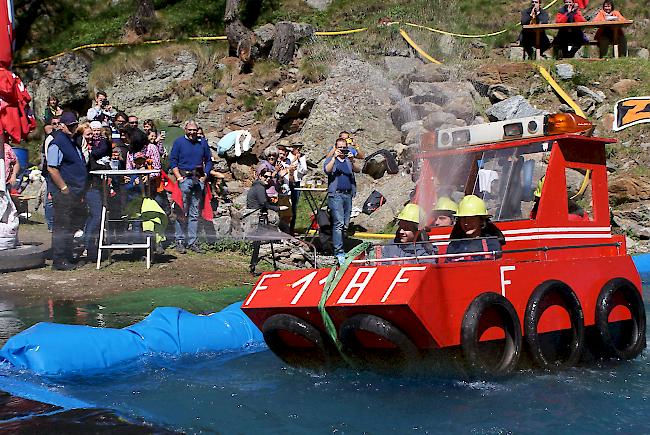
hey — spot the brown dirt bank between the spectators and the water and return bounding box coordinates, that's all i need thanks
[0,225,256,303]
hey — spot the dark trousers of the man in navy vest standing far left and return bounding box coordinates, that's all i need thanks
[52,192,84,264]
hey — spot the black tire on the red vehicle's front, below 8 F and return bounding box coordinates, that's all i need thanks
[339,314,420,370]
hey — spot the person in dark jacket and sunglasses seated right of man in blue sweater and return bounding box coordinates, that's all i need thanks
[244,169,288,274]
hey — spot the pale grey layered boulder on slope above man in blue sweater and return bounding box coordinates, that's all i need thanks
[105,50,198,122]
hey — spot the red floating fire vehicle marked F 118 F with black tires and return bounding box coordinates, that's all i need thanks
[242,114,646,376]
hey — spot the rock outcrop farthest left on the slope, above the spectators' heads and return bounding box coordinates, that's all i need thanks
[22,53,91,118]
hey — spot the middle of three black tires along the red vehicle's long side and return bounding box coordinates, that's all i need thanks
[524,280,585,370]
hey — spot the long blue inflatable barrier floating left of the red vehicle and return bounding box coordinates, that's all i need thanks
[0,302,264,375]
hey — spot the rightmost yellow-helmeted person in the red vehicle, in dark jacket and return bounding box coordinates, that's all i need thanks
[447,195,505,261]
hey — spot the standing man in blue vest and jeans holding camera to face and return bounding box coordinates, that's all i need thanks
[323,138,361,264]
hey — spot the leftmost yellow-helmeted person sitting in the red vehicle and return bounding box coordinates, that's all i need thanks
[382,204,435,262]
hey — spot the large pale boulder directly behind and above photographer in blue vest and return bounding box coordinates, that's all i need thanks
[302,57,400,163]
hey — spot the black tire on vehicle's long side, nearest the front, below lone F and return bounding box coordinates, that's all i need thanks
[461,292,522,378]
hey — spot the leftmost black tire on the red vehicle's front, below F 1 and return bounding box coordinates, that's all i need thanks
[262,314,335,368]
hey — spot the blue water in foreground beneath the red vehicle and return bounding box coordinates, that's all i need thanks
[1,288,650,434]
